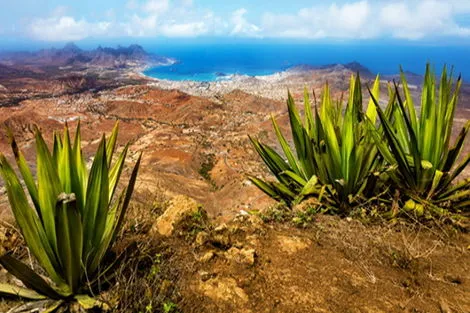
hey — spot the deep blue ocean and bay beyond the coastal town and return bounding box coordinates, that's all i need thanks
[144,42,470,81]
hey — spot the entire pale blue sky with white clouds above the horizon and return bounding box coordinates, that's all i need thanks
[0,0,470,45]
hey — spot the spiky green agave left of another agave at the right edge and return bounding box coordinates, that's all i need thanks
[250,75,386,210]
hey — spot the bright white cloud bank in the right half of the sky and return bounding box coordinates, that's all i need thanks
[261,0,470,40]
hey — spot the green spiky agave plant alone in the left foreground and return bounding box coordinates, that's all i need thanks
[0,124,140,311]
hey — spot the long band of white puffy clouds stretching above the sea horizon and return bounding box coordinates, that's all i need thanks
[29,0,470,41]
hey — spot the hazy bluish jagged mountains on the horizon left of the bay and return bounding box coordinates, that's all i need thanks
[0,43,174,68]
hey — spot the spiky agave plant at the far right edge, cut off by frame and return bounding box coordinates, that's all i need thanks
[372,64,470,208]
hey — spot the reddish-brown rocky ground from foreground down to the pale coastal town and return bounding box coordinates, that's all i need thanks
[0,62,470,312]
